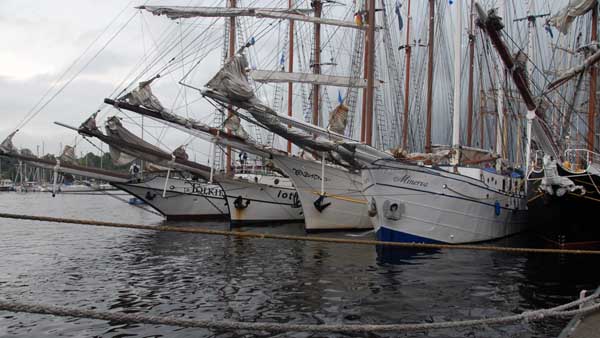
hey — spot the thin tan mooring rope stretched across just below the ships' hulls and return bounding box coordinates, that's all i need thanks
[0,213,600,255]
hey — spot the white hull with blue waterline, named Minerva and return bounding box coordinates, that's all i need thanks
[363,161,527,244]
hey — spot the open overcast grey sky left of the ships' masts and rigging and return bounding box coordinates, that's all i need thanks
[0,0,223,160]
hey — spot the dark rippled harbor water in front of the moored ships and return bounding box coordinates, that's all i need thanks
[0,192,600,338]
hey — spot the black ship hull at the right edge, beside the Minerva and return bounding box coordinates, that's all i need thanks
[528,166,600,249]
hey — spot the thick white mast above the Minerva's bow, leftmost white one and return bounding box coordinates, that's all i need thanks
[452,0,463,152]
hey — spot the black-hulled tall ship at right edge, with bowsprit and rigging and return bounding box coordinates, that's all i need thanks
[478,0,600,248]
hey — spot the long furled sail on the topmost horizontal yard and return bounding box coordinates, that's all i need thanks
[138,6,367,29]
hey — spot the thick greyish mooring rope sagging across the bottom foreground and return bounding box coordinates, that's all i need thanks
[0,292,600,333]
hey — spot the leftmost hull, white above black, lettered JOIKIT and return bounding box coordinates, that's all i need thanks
[112,176,229,220]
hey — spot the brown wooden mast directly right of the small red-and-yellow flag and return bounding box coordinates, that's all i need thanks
[365,0,375,145]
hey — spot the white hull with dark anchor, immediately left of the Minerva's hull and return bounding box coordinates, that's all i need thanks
[273,156,373,231]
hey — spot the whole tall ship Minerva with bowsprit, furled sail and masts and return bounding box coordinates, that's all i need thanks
[204,1,527,243]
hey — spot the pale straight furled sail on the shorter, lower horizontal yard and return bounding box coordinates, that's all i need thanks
[250,70,380,88]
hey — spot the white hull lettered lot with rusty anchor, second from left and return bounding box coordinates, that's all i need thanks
[218,175,304,226]
